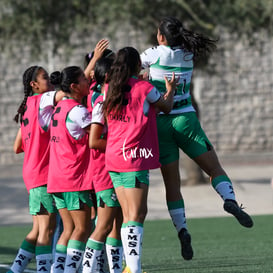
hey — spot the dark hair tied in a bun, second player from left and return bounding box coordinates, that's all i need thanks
[50,66,83,93]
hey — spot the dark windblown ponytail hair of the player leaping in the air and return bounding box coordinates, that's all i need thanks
[158,17,217,60]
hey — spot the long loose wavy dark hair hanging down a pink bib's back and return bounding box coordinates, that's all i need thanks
[103,47,141,116]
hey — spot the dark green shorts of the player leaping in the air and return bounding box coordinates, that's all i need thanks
[157,112,213,165]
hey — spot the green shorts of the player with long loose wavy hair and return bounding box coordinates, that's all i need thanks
[109,170,149,188]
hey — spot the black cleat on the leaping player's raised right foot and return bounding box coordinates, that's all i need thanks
[224,199,253,228]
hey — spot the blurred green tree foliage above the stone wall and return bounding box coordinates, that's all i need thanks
[0,0,273,56]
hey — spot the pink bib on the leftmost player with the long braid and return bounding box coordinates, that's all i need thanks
[21,94,50,191]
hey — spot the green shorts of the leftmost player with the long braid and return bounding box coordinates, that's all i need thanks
[29,185,57,215]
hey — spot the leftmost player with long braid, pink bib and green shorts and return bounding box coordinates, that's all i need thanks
[11,66,64,273]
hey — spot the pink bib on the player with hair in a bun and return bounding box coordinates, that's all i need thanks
[47,99,91,193]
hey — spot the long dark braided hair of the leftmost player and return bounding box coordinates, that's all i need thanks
[13,65,44,123]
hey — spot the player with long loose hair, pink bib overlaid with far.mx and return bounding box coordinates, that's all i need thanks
[102,47,176,273]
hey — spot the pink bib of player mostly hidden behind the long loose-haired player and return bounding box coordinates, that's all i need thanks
[91,95,113,192]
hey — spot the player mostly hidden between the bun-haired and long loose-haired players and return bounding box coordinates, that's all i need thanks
[83,57,123,273]
